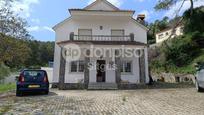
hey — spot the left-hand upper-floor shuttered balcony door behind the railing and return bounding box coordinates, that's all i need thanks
[78,29,92,40]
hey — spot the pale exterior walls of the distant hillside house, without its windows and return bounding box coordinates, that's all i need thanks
[156,26,183,43]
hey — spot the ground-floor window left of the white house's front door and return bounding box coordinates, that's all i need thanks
[71,60,84,72]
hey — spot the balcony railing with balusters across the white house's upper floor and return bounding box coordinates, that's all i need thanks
[70,33,134,41]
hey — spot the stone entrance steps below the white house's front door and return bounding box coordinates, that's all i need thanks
[88,83,118,90]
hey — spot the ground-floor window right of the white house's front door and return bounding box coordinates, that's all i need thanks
[121,61,132,73]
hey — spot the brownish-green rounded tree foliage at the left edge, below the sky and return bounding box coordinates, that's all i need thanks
[0,34,30,67]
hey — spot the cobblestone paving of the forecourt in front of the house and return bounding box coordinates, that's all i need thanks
[0,88,204,115]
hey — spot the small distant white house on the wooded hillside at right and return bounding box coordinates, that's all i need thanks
[155,25,184,43]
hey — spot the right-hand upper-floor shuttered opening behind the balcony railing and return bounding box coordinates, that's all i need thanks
[111,30,125,41]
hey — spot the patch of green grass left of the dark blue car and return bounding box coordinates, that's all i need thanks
[0,83,16,93]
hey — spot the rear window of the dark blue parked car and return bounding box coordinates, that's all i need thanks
[23,70,46,81]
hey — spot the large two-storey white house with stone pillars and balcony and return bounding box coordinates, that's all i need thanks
[53,0,149,89]
